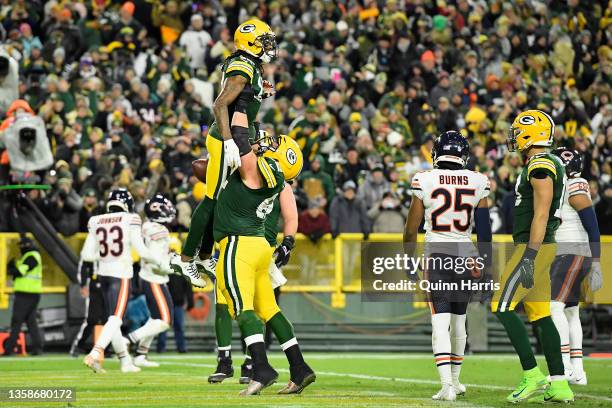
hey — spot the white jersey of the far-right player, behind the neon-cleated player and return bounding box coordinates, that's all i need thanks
[555,177,591,256]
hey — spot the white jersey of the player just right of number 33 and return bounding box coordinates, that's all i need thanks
[140,221,171,284]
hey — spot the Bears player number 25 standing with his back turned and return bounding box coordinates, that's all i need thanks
[404,131,491,401]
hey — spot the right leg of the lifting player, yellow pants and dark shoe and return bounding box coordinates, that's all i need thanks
[255,258,316,394]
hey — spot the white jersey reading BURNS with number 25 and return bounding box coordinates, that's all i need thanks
[411,169,490,242]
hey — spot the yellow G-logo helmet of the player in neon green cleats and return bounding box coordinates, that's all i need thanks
[507,109,555,152]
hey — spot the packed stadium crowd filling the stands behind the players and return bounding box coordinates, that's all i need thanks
[0,0,612,236]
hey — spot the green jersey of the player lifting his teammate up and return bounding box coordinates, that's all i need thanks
[213,157,285,242]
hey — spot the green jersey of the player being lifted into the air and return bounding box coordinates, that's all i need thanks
[209,53,263,143]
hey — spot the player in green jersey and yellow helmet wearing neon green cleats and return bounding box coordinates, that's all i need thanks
[491,109,574,402]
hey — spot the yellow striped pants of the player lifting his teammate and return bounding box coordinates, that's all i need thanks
[215,236,280,322]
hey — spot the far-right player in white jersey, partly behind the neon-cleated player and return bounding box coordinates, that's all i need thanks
[550,147,603,385]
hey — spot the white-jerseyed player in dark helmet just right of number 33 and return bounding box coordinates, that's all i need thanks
[128,194,176,367]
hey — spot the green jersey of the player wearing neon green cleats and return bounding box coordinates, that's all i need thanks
[512,153,566,243]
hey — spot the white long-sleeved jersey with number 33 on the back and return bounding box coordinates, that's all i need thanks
[81,212,151,278]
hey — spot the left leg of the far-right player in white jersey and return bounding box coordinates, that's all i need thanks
[550,255,580,378]
